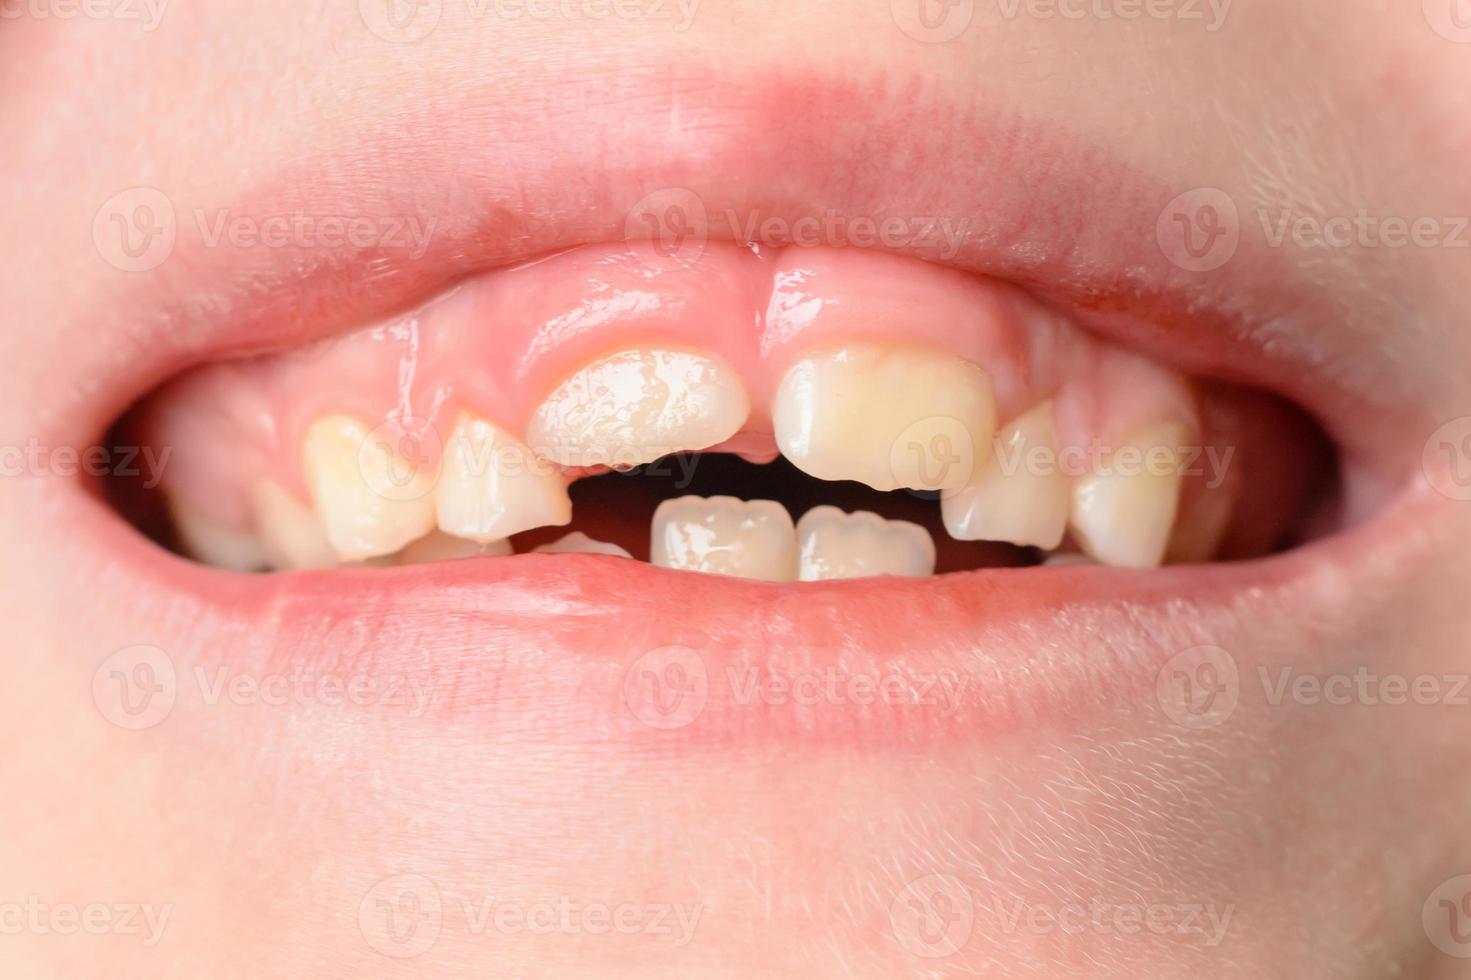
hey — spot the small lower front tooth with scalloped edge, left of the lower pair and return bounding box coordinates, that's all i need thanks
[649,496,797,581]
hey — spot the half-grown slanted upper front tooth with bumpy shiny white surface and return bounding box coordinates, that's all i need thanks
[527,347,750,468]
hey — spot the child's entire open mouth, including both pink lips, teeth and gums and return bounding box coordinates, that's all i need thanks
[40,66,1414,747]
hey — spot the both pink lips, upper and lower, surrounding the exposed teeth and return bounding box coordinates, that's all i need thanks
[37,62,1433,745]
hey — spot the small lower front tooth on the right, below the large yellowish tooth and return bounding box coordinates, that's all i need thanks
[797,506,934,581]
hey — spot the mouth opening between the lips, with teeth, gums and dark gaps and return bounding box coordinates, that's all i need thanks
[114,243,1333,583]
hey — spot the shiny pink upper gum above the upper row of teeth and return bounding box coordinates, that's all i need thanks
[143,243,1196,524]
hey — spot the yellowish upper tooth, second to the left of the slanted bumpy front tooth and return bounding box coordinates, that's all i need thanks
[303,415,435,561]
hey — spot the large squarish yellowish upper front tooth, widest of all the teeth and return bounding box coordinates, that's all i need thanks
[771,346,996,490]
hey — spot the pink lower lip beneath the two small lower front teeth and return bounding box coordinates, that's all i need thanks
[71,470,1436,748]
